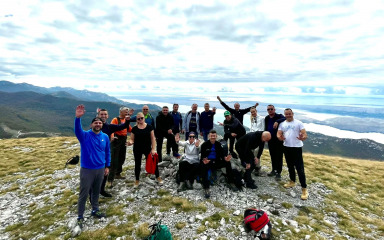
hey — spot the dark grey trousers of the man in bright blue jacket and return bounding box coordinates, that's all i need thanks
[77,168,104,216]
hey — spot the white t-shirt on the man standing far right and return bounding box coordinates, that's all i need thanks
[279,119,304,147]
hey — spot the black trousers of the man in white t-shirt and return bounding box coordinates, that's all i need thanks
[284,147,307,188]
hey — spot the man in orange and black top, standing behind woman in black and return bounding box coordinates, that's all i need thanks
[107,107,132,188]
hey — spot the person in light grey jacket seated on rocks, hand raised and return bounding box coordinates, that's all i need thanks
[175,132,200,192]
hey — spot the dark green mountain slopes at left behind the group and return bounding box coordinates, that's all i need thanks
[0,92,159,138]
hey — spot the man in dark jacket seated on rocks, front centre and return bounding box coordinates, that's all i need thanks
[200,129,239,198]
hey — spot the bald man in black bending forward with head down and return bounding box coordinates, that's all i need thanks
[235,131,271,189]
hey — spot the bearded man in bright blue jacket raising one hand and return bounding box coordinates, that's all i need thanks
[75,105,111,228]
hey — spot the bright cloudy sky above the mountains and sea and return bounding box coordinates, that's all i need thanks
[0,0,384,96]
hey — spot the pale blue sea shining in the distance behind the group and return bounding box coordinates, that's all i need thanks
[111,92,384,144]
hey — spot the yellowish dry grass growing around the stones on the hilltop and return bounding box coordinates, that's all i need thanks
[0,137,384,240]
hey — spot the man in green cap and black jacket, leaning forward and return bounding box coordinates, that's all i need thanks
[219,111,246,158]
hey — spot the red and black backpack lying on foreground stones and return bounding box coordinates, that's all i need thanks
[243,208,272,240]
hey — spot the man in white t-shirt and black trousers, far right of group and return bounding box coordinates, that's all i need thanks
[277,108,308,200]
